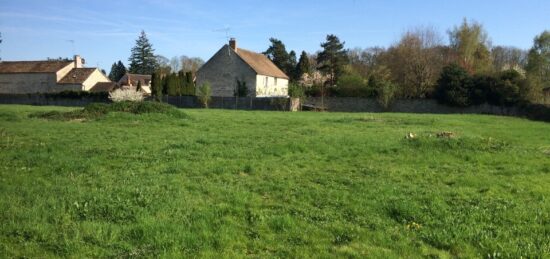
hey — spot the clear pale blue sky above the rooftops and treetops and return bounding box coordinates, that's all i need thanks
[0,0,550,71]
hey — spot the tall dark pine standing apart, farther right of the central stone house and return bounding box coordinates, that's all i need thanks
[317,34,348,86]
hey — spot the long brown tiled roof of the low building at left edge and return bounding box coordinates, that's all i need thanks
[0,60,73,74]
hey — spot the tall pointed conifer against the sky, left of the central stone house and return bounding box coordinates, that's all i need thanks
[128,31,158,75]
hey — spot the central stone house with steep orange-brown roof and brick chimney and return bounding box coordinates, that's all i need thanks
[196,38,288,97]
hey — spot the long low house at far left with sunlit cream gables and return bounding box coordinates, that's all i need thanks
[0,55,113,94]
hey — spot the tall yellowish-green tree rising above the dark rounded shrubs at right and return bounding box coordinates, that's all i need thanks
[448,19,491,74]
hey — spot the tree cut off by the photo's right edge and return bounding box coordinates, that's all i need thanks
[526,31,550,101]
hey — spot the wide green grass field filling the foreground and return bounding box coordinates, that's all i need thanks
[0,105,550,258]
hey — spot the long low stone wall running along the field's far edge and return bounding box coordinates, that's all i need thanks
[0,94,550,122]
